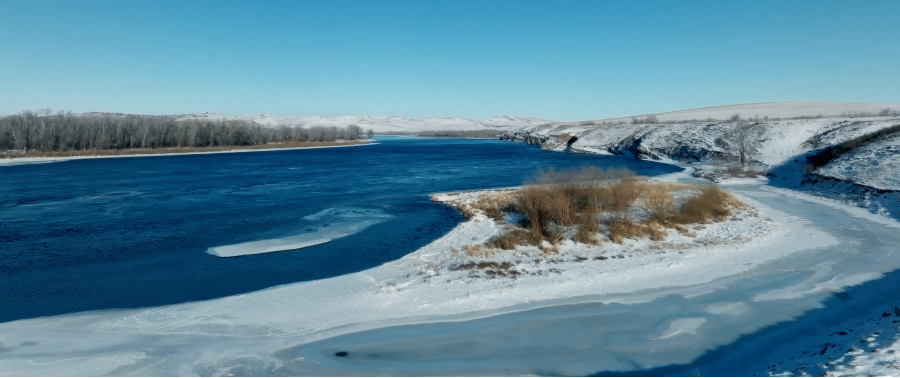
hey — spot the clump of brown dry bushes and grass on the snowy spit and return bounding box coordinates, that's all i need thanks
[466,167,745,252]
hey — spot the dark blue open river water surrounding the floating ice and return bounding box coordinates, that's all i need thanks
[0,137,679,322]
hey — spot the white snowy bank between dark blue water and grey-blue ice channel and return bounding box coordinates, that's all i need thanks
[0,170,872,375]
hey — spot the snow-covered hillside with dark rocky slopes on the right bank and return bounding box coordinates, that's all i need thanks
[502,102,900,213]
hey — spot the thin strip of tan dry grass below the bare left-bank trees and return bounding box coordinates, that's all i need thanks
[0,140,369,159]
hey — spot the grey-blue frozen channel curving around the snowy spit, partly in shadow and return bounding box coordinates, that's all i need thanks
[276,186,900,376]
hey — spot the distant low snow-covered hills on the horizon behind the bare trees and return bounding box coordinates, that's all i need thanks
[171,113,553,132]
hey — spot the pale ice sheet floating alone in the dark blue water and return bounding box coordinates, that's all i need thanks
[213,208,394,257]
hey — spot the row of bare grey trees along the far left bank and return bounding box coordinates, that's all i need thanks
[0,109,372,152]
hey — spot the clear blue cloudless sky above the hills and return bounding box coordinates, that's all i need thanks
[0,0,900,121]
